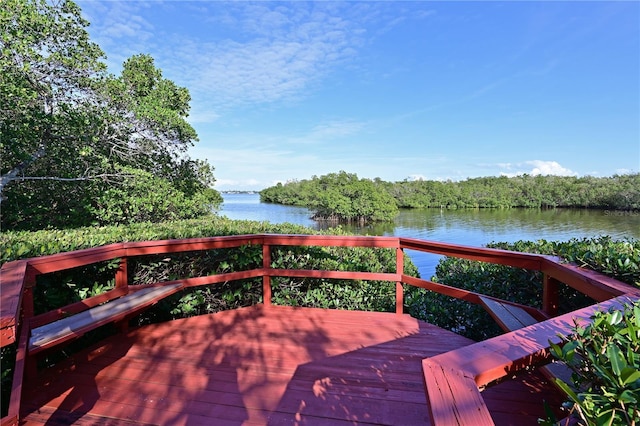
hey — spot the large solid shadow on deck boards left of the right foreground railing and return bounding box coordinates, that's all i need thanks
[269,320,472,426]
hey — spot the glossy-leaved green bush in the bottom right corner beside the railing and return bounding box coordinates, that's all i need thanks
[551,302,640,426]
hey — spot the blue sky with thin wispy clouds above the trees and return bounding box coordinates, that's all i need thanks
[78,0,640,190]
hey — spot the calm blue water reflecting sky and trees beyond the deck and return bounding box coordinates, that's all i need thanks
[220,194,640,278]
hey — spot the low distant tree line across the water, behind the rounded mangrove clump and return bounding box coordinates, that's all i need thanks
[260,172,640,210]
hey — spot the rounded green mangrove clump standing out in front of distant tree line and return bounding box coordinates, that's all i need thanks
[260,171,398,223]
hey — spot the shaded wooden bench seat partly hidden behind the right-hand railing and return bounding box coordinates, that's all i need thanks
[480,296,572,386]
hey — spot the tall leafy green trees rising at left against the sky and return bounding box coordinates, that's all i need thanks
[0,0,222,230]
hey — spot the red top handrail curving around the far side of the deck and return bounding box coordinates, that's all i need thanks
[0,235,638,352]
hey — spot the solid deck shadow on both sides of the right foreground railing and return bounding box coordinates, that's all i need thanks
[269,322,562,426]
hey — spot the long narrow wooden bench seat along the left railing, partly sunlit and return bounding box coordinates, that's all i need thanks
[28,283,183,355]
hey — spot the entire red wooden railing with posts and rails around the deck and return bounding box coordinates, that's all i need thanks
[0,234,640,426]
